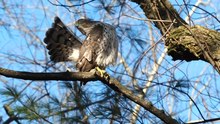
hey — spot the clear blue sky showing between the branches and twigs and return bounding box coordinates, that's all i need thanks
[0,0,220,123]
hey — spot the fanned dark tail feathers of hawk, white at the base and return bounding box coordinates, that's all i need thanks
[44,17,82,62]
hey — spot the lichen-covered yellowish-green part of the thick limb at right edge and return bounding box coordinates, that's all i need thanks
[165,26,220,61]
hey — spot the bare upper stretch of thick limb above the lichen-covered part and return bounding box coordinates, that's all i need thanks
[132,0,187,34]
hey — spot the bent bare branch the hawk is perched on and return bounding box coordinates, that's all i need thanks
[0,68,178,124]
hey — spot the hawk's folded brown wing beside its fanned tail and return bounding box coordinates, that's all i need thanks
[76,24,104,71]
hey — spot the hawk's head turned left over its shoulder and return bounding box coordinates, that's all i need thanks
[75,19,96,35]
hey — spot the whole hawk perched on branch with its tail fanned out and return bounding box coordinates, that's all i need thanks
[44,17,118,72]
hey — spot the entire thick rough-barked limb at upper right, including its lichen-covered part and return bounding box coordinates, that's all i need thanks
[132,0,220,73]
